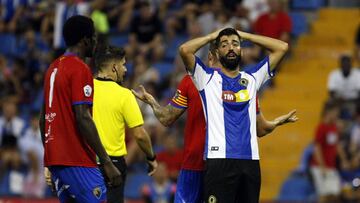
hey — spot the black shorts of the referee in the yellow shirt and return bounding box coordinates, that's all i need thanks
[99,156,127,203]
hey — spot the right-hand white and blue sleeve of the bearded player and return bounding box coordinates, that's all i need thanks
[246,56,275,91]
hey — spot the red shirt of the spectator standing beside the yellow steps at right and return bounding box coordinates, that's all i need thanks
[311,123,339,168]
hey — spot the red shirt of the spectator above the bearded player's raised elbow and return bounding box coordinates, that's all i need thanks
[254,12,291,39]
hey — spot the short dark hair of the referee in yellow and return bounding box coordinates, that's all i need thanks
[94,46,125,70]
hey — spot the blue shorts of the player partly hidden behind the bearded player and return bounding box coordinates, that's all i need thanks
[174,169,204,203]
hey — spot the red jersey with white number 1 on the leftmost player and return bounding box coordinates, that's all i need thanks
[44,54,96,167]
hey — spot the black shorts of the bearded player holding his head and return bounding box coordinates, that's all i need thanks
[204,159,261,203]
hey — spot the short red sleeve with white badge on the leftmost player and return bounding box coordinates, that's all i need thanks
[71,63,94,105]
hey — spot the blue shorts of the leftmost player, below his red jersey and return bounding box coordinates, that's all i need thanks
[49,166,106,203]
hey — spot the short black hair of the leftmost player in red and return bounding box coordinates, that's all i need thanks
[63,15,95,47]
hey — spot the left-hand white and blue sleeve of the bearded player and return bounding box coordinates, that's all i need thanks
[188,56,214,91]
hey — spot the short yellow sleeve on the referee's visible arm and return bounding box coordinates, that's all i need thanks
[122,90,144,128]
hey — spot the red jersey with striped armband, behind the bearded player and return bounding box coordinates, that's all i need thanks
[170,75,206,170]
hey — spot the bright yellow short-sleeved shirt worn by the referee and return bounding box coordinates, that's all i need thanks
[93,79,144,156]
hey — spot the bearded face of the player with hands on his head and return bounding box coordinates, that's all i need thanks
[218,35,241,71]
